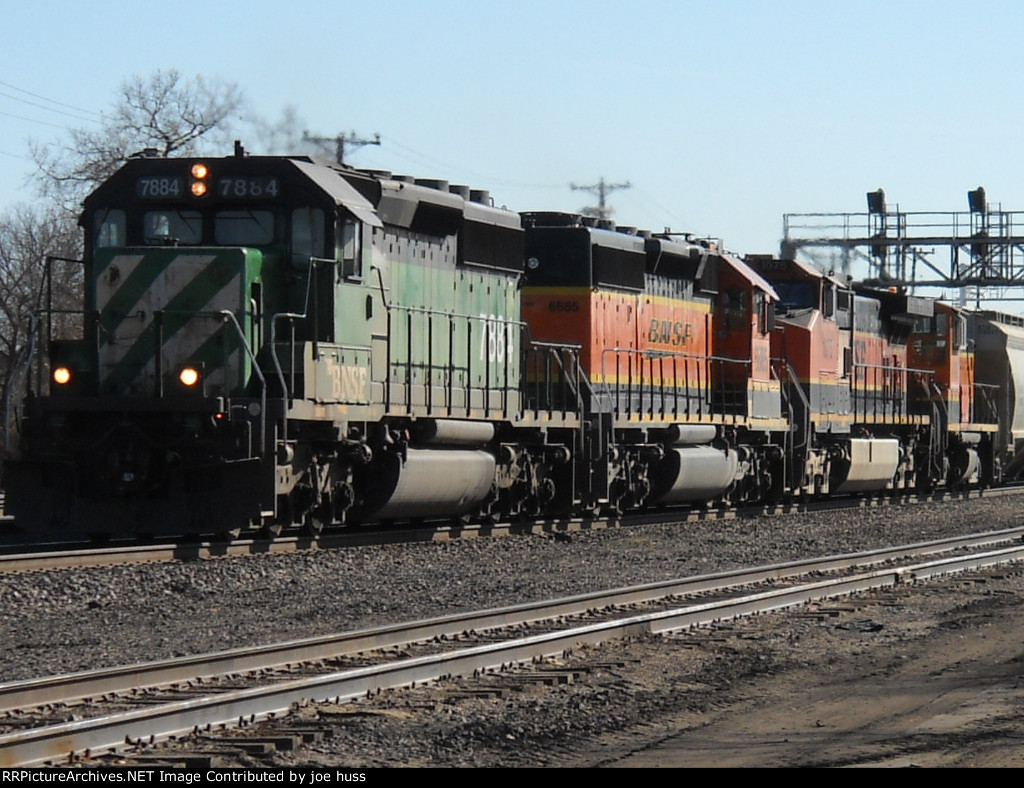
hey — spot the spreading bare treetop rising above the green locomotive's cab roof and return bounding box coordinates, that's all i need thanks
[30,69,244,212]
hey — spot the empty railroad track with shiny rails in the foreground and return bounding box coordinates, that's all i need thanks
[0,528,1024,767]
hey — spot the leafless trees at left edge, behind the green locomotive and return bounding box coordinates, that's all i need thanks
[0,69,258,449]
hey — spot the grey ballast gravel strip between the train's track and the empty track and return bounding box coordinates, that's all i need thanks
[0,495,1020,682]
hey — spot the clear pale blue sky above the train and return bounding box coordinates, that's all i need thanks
[0,0,1024,253]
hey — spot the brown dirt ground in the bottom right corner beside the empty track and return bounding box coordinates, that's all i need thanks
[601,573,1024,768]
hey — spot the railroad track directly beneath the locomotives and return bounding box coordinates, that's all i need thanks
[0,485,1024,573]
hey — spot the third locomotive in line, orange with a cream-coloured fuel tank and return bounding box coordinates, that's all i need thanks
[748,256,910,494]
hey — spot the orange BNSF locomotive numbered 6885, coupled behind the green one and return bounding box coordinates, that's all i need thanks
[522,213,788,511]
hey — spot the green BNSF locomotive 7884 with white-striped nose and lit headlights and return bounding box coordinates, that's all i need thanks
[4,145,529,535]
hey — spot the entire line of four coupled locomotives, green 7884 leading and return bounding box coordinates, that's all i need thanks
[4,146,1013,535]
